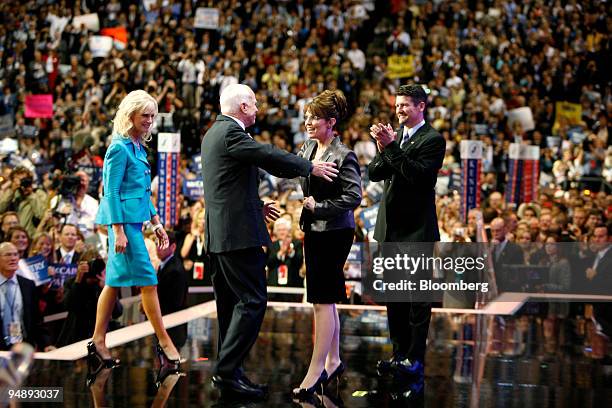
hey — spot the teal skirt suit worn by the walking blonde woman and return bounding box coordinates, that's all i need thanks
[96,134,157,287]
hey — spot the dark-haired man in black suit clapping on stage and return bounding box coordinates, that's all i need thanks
[368,85,446,399]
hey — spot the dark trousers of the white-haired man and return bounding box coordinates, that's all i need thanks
[210,247,267,377]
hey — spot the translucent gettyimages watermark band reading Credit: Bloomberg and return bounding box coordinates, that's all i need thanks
[358,242,612,308]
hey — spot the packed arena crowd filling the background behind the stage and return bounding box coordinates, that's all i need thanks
[0,0,612,354]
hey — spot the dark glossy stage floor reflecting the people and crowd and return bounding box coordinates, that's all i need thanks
[24,304,612,408]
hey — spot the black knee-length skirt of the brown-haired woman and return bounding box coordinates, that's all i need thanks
[304,228,354,304]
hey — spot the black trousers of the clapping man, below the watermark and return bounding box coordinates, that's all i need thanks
[387,302,431,363]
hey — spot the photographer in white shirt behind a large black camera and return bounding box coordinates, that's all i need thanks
[50,170,99,239]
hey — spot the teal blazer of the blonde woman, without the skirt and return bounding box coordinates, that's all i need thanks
[96,134,157,225]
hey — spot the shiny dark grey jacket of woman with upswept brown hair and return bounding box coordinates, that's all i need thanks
[298,137,361,232]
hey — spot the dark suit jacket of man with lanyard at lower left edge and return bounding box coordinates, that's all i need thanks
[0,275,50,351]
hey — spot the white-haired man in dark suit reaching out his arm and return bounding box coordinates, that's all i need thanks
[202,84,338,397]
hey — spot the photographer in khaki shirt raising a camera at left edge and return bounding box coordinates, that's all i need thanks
[0,166,47,235]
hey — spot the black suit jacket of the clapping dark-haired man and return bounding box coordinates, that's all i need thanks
[368,123,446,242]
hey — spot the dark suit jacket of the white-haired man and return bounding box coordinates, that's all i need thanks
[202,115,312,253]
